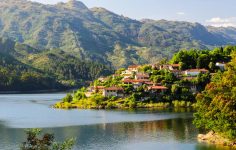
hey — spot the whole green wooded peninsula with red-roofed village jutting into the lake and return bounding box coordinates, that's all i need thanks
[54,46,236,109]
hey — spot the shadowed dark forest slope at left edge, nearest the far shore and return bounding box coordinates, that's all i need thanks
[0,54,63,91]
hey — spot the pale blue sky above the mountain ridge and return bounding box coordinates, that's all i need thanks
[30,0,236,27]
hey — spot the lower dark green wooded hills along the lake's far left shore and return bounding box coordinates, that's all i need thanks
[0,38,111,91]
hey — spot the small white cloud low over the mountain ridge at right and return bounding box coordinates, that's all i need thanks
[206,17,236,27]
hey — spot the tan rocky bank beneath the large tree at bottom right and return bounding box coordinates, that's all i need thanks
[197,131,236,149]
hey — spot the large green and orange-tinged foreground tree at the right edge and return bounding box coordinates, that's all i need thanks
[194,52,236,146]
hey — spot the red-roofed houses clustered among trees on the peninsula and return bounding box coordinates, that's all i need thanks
[87,63,225,97]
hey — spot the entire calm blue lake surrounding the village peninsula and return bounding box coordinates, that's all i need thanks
[0,93,230,150]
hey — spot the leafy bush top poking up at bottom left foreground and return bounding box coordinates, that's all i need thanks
[20,129,75,150]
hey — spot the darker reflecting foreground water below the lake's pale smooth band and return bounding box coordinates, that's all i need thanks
[0,118,229,150]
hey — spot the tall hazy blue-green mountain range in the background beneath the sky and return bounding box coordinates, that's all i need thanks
[0,0,236,68]
